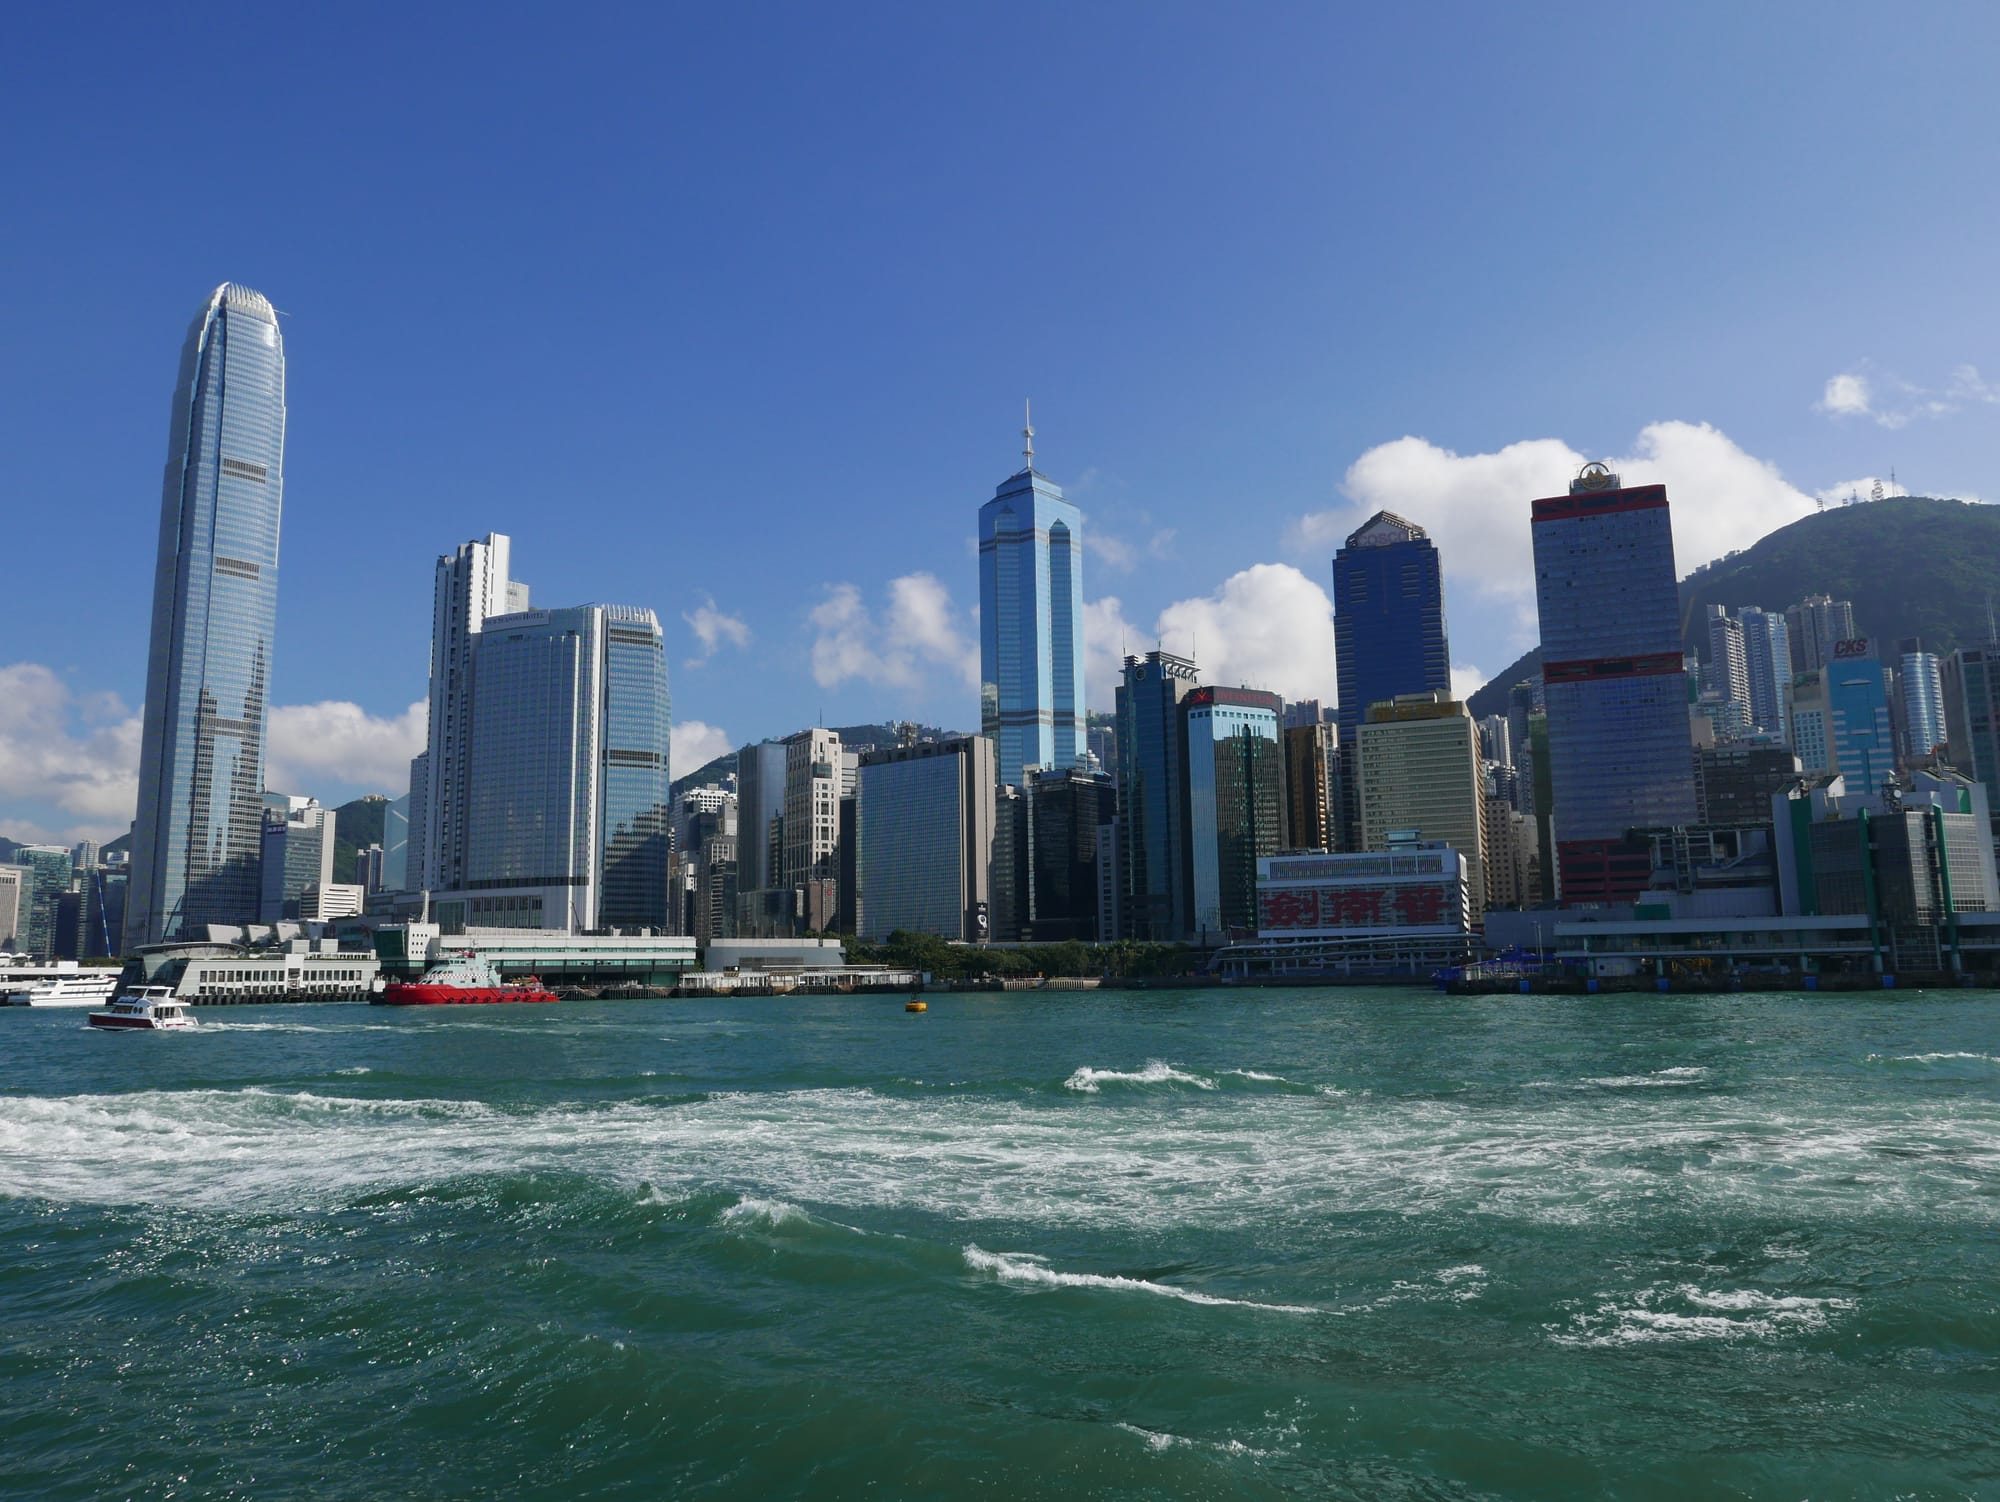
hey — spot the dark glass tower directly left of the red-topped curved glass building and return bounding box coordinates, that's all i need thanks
[1118,652,1196,942]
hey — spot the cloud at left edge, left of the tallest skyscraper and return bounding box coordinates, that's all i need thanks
[0,662,140,844]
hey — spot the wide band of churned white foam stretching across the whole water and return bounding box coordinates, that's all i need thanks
[0,1066,2000,1240]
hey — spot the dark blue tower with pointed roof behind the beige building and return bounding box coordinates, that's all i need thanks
[1334,512,1452,850]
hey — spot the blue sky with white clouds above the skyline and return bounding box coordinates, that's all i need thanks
[0,4,2000,838]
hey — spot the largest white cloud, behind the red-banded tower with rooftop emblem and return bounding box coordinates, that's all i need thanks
[1288,422,1816,650]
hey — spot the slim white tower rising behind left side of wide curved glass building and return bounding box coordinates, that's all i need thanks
[410,532,528,892]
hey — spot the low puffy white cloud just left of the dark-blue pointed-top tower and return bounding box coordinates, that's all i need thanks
[1154,564,1334,702]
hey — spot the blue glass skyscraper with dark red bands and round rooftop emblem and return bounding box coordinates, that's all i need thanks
[1532,464,1696,904]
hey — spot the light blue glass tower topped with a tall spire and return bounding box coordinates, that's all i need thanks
[980,412,1084,786]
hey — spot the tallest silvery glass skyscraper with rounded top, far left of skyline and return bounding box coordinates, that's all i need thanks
[126,282,284,946]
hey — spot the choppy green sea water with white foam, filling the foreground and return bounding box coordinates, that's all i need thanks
[0,990,2000,1498]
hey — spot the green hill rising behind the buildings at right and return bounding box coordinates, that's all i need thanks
[1470,496,2000,716]
